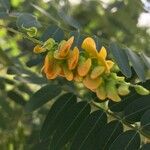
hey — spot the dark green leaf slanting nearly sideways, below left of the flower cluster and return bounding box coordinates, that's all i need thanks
[25,84,61,112]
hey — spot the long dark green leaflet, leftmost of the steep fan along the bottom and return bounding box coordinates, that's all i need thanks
[40,93,77,141]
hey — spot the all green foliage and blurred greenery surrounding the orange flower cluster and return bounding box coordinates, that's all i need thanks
[0,0,150,150]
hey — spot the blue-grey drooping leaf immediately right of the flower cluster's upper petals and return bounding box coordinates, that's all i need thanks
[109,43,132,78]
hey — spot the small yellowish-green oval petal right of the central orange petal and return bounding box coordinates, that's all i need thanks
[90,66,105,79]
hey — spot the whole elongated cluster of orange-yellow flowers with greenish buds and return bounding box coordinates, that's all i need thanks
[34,37,149,102]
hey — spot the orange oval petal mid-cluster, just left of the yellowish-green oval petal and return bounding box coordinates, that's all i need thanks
[77,58,92,77]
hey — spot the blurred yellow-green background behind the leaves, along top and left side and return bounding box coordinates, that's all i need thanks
[0,0,150,150]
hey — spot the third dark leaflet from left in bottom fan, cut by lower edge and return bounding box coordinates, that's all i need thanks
[70,110,107,150]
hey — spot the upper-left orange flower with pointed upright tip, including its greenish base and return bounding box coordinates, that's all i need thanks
[54,36,74,59]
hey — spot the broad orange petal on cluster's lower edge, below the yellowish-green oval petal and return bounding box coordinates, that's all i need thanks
[83,75,102,90]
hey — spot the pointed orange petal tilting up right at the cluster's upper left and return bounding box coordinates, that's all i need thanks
[58,36,74,58]
